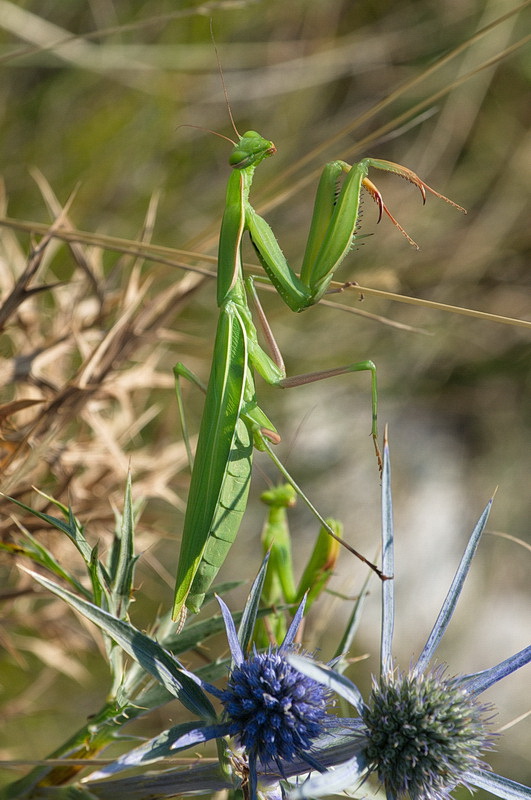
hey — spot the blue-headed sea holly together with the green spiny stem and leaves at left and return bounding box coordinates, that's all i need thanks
[0,466,354,800]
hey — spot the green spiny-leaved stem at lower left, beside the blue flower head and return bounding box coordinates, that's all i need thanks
[0,479,251,800]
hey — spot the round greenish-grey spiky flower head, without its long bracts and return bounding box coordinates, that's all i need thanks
[361,667,493,800]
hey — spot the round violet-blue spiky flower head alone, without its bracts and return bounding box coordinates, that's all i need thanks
[221,650,330,764]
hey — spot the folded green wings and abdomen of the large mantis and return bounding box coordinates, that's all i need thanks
[173,303,252,624]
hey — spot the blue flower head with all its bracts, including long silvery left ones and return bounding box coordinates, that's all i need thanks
[21,558,358,800]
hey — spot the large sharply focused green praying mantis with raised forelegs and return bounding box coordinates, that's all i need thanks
[173,126,461,626]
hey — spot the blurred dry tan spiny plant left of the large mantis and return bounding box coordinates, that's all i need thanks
[3,187,201,505]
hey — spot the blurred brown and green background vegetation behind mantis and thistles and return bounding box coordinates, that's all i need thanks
[0,0,531,784]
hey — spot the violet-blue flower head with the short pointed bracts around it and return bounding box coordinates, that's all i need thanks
[156,559,336,800]
